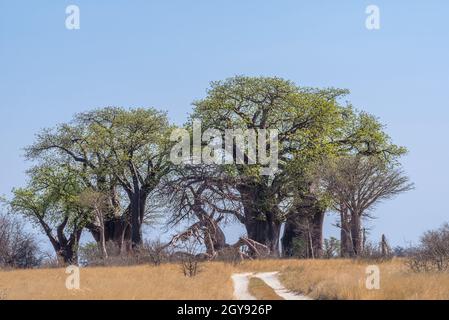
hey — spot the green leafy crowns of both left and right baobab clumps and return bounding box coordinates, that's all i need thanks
[7,76,406,258]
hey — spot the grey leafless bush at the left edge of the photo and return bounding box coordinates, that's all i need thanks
[0,214,42,269]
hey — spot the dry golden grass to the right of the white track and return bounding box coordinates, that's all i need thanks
[281,260,449,300]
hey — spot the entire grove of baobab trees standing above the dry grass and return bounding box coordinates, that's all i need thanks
[4,76,412,263]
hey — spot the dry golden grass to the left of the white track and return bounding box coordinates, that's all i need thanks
[0,263,233,300]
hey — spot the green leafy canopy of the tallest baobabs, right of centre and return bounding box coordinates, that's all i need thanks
[191,76,406,225]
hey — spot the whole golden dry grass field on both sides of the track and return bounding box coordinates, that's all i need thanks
[0,260,449,300]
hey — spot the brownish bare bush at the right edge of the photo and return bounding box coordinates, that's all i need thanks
[407,223,449,272]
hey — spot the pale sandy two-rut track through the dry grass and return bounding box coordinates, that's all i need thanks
[232,272,311,300]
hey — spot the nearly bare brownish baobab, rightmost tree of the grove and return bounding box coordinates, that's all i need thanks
[321,155,413,256]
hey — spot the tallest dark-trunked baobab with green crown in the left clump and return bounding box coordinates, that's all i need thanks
[77,108,171,248]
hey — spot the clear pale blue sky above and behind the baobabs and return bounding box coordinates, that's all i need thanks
[0,0,449,245]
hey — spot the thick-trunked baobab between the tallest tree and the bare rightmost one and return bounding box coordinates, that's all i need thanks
[282,106,406,258]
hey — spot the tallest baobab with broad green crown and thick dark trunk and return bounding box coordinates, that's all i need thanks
[192,77,347,254]
